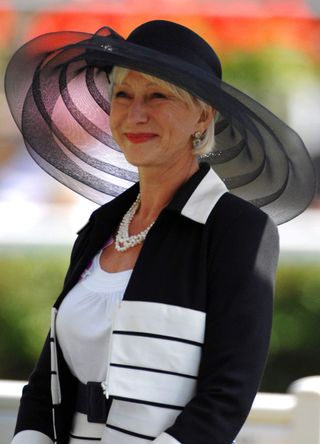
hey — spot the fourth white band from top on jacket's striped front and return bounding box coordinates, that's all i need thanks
[108,399,181,436]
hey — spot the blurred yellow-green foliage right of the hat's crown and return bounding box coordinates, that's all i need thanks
[222,46,320,120]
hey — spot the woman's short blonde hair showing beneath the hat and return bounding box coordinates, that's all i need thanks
[109,66,215,156]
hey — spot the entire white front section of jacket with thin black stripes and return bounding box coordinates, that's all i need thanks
[104,300,206,444]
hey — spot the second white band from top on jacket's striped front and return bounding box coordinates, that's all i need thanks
[112,334,201,376]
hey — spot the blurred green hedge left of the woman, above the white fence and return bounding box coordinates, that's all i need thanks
[0,251,67,379]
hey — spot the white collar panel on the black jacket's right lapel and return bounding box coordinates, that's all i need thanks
[181,168,228,224]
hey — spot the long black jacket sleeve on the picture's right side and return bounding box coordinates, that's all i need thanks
[153,209,279,444]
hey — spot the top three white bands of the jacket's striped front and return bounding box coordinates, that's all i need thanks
[105,300,206,408]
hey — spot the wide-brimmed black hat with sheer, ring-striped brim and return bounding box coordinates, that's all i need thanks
[5,20,315,224]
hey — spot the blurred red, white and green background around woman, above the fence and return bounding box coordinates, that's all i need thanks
[0,0,320,392]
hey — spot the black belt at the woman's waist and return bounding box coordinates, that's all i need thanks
[75,381,111,424]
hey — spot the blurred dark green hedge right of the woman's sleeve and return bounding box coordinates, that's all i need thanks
[261,263,320,392]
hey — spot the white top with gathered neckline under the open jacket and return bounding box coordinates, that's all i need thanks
[56,250,132,384]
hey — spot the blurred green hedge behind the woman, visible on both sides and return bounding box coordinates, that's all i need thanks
[0,251,320,392]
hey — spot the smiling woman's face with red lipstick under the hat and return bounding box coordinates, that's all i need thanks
[110,71,202,167]
